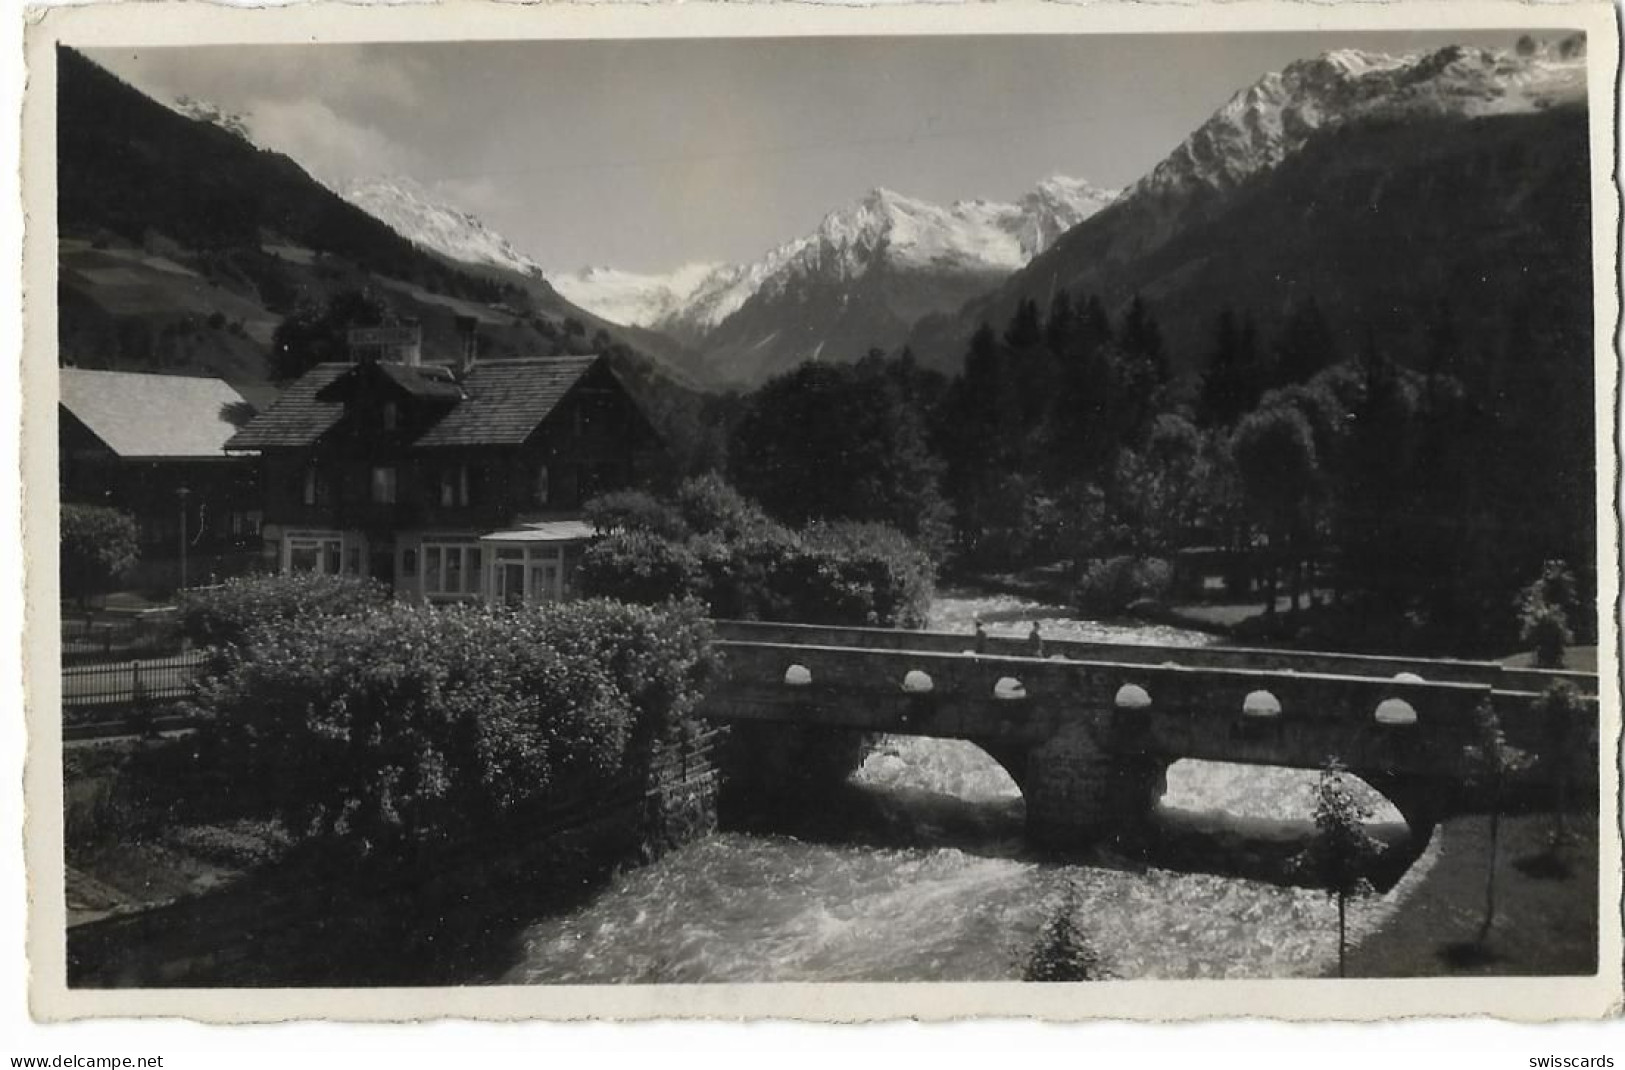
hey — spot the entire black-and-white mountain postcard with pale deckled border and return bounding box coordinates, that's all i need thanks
[24,5,1620,1018]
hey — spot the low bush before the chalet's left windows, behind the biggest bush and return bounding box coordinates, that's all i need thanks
[180,572,388,646]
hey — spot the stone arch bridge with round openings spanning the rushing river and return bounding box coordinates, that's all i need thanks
[700,621,1599,847]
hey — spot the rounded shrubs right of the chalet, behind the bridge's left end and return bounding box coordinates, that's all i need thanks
[580,478,934,628]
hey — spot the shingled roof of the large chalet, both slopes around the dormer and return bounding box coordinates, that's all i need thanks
[228,356,600,449]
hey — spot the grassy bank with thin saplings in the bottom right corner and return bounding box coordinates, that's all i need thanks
[1349,815,1599,977]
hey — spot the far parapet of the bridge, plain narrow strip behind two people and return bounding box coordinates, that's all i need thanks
[713,620,1597,696]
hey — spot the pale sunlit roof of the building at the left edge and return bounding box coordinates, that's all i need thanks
[59,368,254,460]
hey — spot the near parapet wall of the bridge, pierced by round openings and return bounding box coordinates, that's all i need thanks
[705,639,1597,784]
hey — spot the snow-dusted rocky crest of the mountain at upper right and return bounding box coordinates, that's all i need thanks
[908,39,1584,371]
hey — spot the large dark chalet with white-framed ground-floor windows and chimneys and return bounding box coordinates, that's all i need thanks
[229,353,663,603]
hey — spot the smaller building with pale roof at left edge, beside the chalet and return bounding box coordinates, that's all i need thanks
[57,368,262,589]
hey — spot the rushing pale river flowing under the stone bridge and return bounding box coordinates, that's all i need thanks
[504,594,1432,984]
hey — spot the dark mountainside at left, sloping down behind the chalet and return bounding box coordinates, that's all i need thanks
[57,49,711,413]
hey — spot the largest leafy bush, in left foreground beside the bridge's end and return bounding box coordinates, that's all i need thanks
[184,602,710,859]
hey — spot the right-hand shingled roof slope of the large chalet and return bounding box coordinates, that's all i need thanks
[416,356,600,446]
